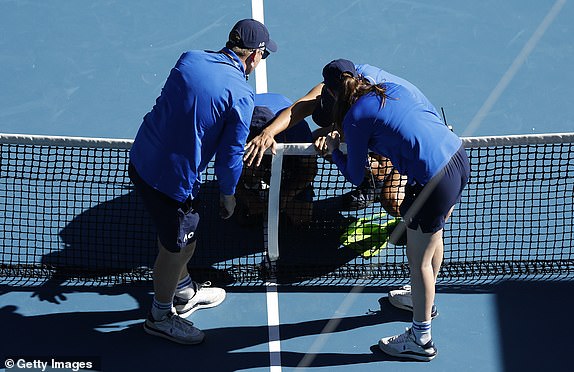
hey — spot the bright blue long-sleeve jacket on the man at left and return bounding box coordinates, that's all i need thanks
[130,48,254,202]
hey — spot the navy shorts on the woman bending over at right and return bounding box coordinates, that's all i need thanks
[400,146,470,233]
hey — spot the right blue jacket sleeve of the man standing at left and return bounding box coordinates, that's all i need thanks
[215,96,253,195]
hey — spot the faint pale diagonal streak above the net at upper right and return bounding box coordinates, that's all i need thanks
[462,0,566,137]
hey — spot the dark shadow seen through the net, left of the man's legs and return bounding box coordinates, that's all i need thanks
[49,191,157,280]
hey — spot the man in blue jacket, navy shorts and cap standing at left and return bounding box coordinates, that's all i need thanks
[129,19,277,344]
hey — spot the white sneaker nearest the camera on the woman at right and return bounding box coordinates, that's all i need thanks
[379,328,438,362]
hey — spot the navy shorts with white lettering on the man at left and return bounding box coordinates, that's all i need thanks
[128,163,199,253]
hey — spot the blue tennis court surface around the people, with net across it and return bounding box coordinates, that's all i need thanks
[0,0,574,371]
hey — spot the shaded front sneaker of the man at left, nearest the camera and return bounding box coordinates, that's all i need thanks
[144,312,205,345]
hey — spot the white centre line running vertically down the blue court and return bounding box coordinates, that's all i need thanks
[251,0,281,372]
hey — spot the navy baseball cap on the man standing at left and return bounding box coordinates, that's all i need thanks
[229,19,277,52]
